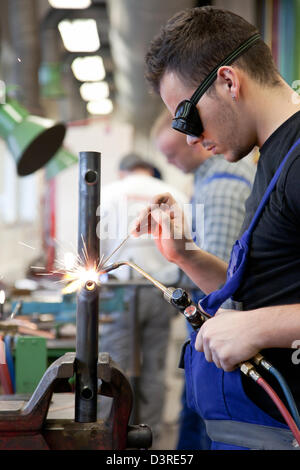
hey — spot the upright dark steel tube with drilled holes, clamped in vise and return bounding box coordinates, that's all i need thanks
[75,152,101,423]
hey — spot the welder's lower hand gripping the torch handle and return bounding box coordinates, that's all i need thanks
[195,309,260,372]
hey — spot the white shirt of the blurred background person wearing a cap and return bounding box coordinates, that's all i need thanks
[100,173,188,285]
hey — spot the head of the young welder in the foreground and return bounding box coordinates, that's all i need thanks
[146,7,282,161]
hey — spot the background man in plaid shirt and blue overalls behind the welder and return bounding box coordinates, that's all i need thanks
[151,110,256,449]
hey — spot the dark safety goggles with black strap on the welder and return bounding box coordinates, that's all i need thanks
[172,33,260,137]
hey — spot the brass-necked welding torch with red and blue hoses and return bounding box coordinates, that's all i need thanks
[101,261,300,445]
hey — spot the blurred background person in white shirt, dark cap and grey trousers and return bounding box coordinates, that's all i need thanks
[100,153,188,446]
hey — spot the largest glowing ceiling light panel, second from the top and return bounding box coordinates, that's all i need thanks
[58,19,100,52]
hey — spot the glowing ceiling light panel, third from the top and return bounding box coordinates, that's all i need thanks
[71,55,105,82]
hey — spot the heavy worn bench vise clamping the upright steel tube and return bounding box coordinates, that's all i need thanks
[0,353,152,450]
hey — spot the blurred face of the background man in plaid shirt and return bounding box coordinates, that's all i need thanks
[151,110,211,173]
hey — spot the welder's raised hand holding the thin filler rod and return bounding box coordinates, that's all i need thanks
[131,193,197,264]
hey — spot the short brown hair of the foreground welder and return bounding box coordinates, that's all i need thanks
[146,6,280,93]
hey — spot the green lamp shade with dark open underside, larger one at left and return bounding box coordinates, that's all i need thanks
[0,100,66,176]
